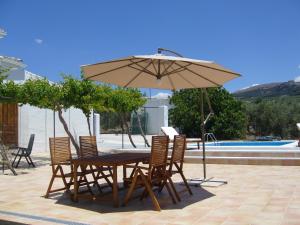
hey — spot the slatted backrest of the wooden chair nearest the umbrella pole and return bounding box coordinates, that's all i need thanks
[169,135,186,170]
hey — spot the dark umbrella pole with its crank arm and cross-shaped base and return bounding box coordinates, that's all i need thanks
[188,89,227,187]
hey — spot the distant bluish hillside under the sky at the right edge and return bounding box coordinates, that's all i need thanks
[233,81,300,99]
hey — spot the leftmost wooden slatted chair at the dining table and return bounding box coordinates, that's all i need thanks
[45,137,92,198]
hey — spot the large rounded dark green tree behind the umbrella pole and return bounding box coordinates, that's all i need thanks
[170,88,246,139]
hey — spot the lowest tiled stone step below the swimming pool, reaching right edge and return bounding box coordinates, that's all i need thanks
[184,156,300,166]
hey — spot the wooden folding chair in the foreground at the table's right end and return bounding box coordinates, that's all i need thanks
[124,136,176,211]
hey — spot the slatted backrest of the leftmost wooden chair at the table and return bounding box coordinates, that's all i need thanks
[49,137,72,165]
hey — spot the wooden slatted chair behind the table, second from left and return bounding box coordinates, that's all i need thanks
[78,136,112,192]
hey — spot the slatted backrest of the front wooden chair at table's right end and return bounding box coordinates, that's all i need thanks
[149,136,169,174]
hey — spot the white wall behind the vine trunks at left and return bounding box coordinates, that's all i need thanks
[19,105,99,151]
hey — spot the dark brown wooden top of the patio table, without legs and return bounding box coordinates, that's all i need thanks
[72,153,150,166]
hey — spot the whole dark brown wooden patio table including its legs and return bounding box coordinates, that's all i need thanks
[72,153,150,207]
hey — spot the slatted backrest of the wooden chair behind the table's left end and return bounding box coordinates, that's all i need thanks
[78,136,98,158]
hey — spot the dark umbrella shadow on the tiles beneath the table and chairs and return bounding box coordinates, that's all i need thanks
[51,183,215,213]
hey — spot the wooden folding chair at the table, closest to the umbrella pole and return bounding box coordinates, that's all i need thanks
[161,135,193,201]
